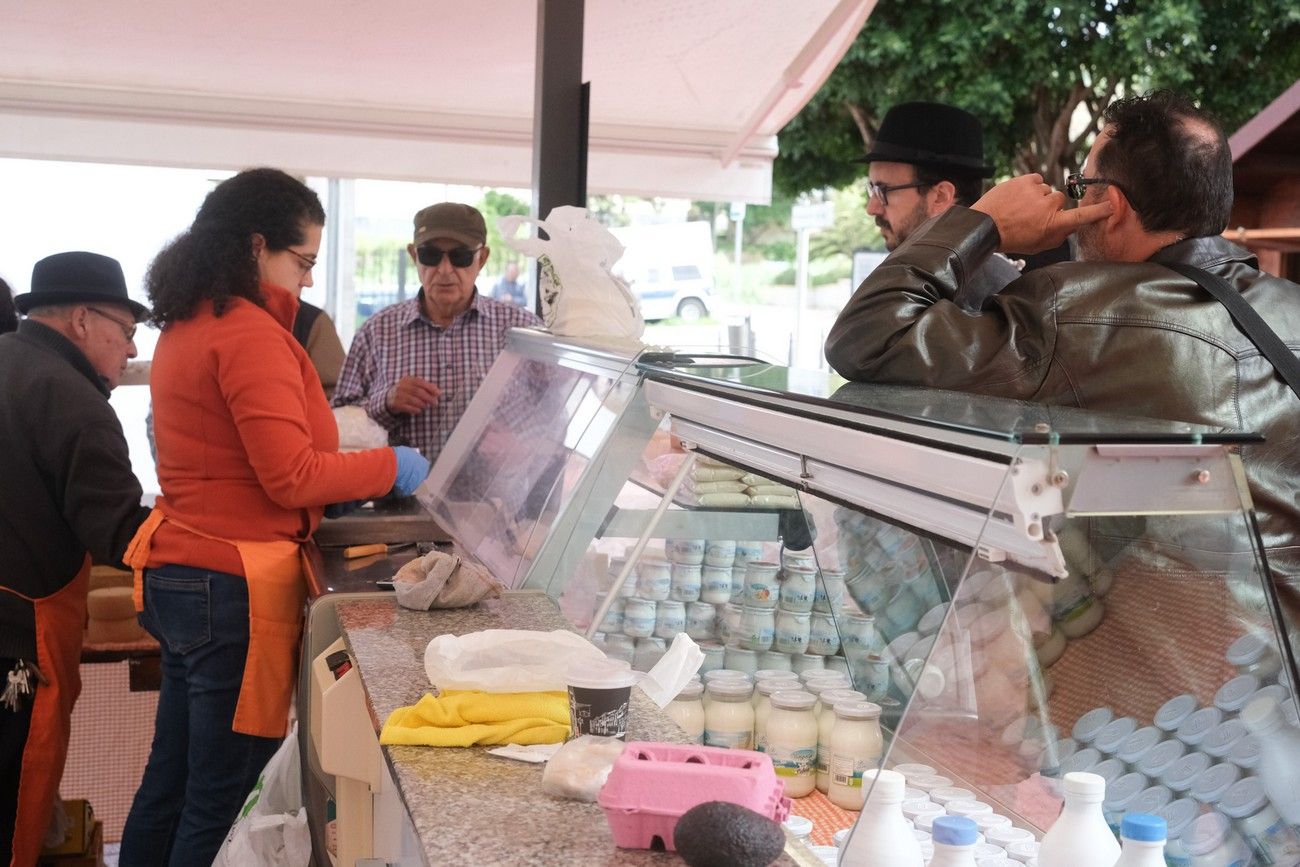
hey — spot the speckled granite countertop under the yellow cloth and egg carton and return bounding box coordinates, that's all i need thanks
[338,591,794,867]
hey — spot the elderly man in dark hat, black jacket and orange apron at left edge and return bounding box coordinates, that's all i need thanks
[0,252,148,864]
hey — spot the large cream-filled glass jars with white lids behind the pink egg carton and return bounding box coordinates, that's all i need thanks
[667,669,884,810]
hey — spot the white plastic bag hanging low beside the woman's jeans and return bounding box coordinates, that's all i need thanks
[212,723,312,867]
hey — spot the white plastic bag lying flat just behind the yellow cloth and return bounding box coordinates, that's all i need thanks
[424,629,605,693]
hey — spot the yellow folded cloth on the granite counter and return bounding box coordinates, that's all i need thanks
[380,690,569,746]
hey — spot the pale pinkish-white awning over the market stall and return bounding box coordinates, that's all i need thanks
[0,0,875,201]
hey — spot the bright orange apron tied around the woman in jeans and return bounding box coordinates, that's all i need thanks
[122,507,307,738]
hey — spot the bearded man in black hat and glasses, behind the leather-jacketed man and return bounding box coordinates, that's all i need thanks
[862,103,1021,311]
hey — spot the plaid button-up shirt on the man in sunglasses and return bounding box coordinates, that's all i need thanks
[333,290,541,461]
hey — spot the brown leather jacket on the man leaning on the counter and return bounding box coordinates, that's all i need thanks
[826,208,1300,582]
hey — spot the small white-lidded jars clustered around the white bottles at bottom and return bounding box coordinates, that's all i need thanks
[835,763,1039,867]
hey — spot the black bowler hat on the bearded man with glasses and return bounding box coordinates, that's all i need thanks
[859,103,993,178]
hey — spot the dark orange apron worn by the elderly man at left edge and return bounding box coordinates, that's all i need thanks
[13,556,90,864]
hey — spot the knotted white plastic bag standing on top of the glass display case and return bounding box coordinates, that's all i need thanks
[497,205,646,341]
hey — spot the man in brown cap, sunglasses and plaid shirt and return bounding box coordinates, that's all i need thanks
[333,201,541,463]
